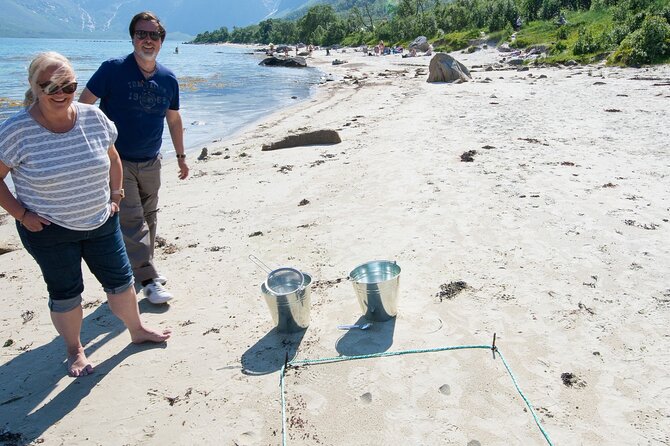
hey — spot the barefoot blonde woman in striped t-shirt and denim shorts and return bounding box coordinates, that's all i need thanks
[0,52,170,376]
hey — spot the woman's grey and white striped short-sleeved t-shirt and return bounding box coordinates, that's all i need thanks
[0,102,118,231]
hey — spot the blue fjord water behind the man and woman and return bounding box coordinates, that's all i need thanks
[0,38,322,154]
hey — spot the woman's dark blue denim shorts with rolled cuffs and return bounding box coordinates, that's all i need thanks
[16,213,134,313]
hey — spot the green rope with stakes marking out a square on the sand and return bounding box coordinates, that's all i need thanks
[279,333,554,446]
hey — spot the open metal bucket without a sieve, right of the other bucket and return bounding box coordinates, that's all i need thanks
[349,260,400,322]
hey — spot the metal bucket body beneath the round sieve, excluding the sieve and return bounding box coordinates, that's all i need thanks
[261,273,312,333]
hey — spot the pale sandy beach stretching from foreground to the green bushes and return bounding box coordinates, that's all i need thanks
[0,48,670,446]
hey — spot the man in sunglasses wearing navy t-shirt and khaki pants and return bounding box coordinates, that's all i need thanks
[79,11,189,304]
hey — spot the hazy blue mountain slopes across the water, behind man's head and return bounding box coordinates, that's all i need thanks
[0,0,319,40]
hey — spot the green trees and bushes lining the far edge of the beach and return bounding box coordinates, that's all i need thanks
[193,0,670,66]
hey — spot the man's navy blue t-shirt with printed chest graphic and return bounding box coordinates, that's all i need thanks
[86,53,179,162]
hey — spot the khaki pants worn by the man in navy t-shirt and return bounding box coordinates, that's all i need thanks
[120,155,161,284]
